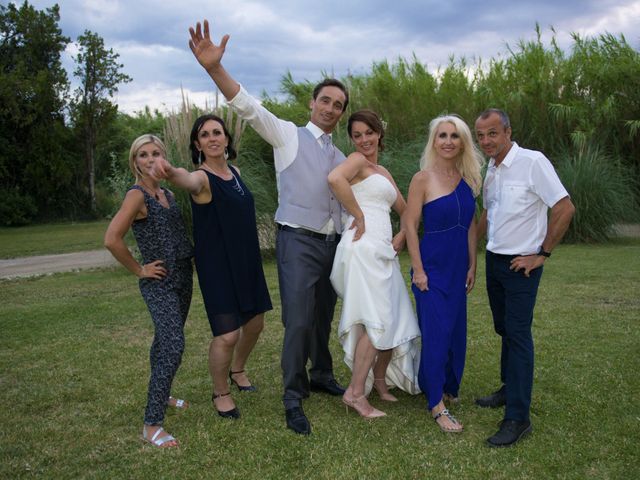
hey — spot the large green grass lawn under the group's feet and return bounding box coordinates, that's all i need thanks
[0,240,640,480]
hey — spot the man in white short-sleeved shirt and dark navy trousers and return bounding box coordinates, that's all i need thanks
[475,109,575,447]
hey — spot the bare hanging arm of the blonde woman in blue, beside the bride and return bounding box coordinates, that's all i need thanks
[402,171,429,291]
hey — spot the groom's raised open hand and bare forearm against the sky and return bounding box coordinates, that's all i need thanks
[189,20,240,100]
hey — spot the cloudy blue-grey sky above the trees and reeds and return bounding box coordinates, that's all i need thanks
[20,0,640,113]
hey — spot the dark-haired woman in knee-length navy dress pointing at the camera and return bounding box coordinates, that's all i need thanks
[159,115,272,419]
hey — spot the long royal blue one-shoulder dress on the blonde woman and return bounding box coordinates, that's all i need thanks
[412,180,475,409]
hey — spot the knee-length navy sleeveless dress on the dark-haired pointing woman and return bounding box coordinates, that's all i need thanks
[191,167,272,336]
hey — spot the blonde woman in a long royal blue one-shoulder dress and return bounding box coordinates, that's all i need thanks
[403,115,482,433]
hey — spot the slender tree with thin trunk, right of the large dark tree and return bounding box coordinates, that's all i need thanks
[71,30,132,214]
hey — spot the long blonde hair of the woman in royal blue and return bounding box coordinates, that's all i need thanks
[420,114,484,196]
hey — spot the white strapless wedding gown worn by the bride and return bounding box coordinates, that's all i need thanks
[331,174,420,394]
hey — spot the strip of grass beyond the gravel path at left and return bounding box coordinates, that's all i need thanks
[0,220,109,259]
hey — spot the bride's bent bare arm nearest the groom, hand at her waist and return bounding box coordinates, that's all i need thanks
[327,152,367,242]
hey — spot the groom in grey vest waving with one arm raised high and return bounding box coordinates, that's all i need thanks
[189,20,349,435]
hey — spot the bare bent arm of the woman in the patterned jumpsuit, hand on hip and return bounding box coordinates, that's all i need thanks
[104,190,167,279]
